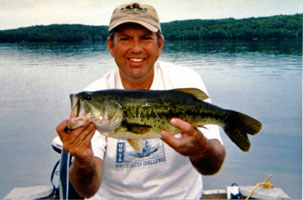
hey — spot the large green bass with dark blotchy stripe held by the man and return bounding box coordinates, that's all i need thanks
[69,88,262,152]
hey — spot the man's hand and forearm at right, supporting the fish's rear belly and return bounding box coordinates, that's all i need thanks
[161,118,226,175]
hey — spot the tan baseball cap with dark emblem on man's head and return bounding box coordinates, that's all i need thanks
[108,3,161,32]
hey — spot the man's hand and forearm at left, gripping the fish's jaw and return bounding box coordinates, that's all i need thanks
[56,120,103,198]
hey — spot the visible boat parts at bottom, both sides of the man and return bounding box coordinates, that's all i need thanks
[4,136,290,200]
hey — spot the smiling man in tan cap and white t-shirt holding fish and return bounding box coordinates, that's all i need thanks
[57,3,225,199]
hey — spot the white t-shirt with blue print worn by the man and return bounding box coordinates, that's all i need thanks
[85,62,222,199]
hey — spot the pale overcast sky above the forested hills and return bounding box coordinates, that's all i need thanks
[0,0,303,30]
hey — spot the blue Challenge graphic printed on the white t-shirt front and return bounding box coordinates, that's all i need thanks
[116,139,166,169]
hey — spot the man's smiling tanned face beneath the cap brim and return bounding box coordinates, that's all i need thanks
[107,24,164,87]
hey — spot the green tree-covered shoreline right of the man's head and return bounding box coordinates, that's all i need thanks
[162,14,302,40]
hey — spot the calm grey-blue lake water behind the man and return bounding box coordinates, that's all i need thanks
[0,41,302,198]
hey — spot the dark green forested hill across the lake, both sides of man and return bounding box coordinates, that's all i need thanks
[0,14,303,43]
